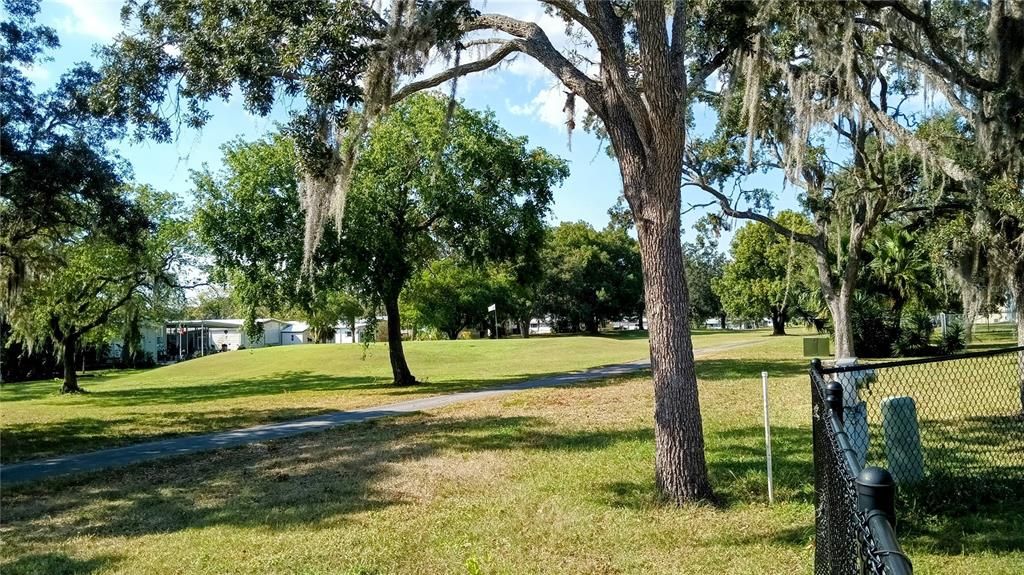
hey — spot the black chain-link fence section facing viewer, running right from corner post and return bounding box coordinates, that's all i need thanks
[821,348,1024,498]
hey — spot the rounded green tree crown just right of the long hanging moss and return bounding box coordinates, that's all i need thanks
[341,95,568,300]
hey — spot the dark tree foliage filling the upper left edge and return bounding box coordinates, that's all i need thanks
[0,0,150,304]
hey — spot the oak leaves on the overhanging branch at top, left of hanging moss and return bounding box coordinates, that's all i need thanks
[94,0,383,139]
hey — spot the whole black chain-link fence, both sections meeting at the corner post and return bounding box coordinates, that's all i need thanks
[811,347,1024,574]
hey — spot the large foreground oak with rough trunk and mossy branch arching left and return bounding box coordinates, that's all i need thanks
[98,0,756,502]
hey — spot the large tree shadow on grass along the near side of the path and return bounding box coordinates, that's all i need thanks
[3,415,650,545]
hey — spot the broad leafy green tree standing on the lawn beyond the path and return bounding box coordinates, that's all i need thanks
[196,94,568,381]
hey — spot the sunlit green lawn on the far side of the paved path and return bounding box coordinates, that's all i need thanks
[0,330,767,462]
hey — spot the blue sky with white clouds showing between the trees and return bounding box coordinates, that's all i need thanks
[27,0,795,247]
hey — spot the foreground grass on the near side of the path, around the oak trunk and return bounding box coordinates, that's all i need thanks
[0,337,1024,575]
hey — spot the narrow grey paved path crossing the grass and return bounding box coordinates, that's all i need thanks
[0,341,757,485]
